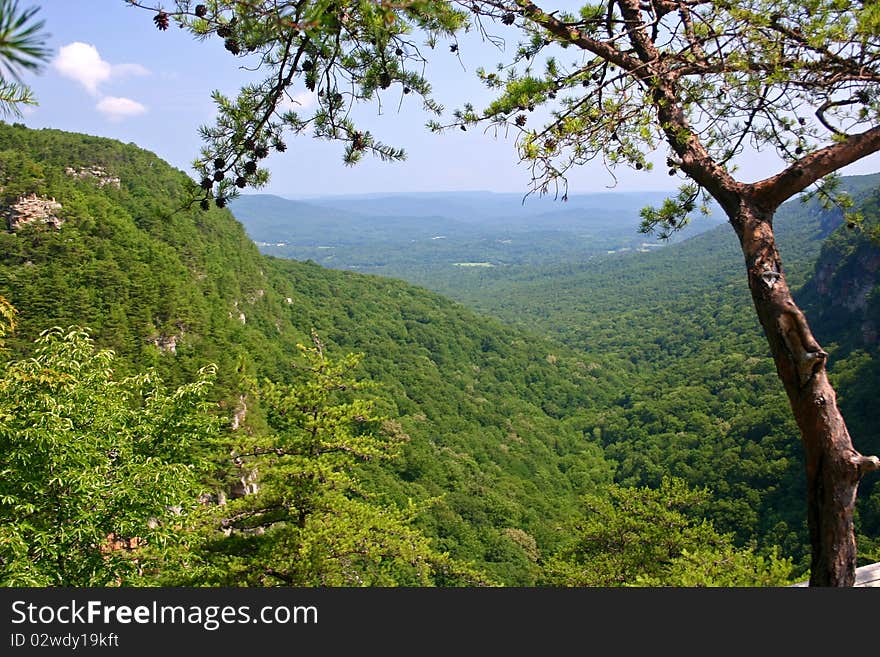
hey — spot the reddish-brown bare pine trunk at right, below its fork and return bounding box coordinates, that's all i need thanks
[728,197,878,586]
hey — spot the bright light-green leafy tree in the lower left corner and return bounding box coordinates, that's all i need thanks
[0,312,219,586]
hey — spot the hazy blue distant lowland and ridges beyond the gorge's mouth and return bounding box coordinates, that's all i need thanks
[230,186,720,288]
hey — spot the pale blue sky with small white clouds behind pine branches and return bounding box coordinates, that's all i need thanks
[13,0,880,198]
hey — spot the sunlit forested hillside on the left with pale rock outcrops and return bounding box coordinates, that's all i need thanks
[0,125,614,584]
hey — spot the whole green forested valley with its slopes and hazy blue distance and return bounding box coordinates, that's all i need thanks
[0,124,880,586]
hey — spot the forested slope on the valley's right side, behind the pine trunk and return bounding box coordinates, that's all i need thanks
[241,165,880,560]
